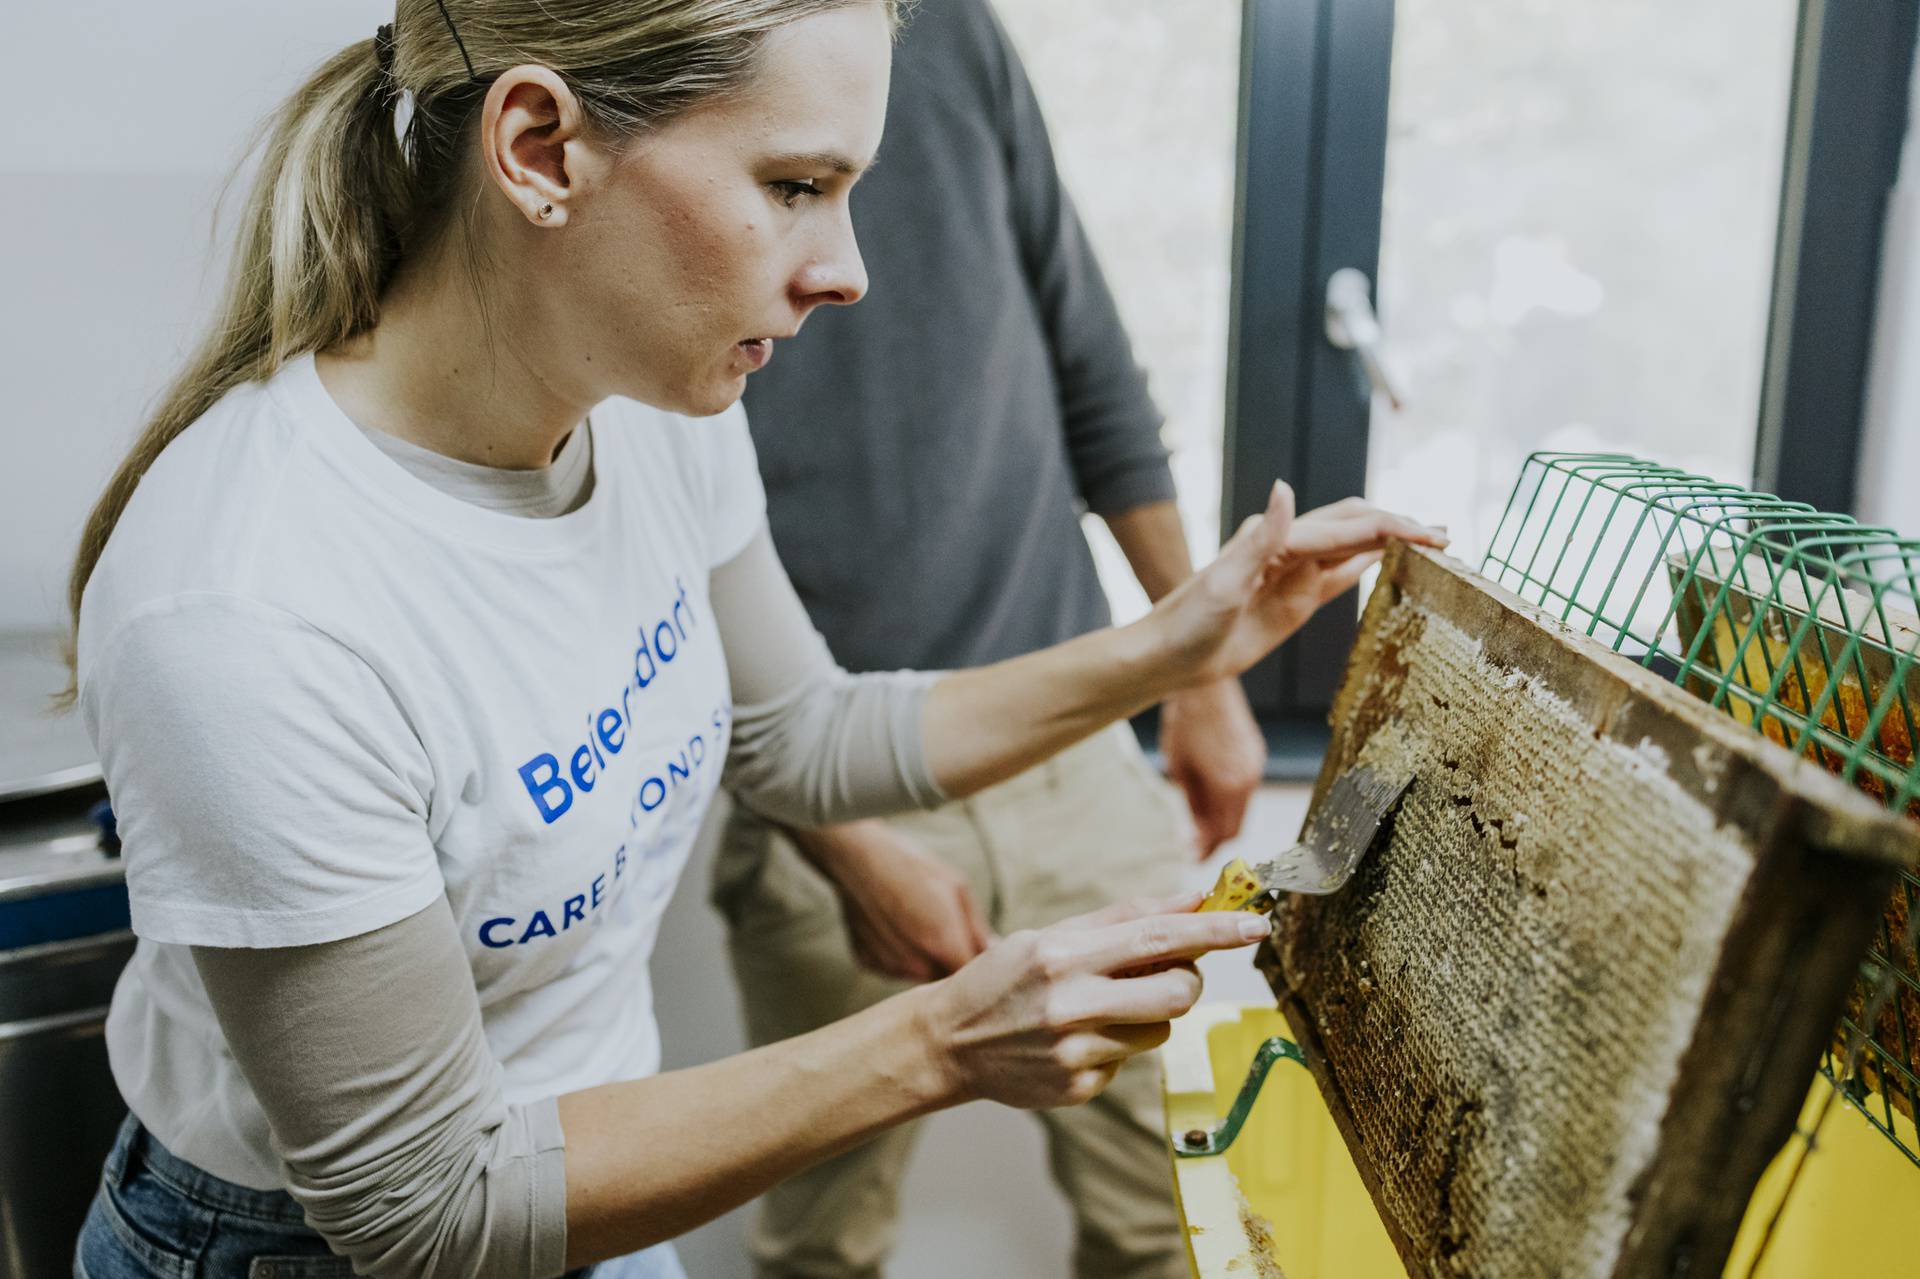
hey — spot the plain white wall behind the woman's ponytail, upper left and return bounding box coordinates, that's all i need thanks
[0,0,392,630]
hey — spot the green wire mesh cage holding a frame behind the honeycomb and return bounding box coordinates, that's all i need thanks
[1480,453,1920,1164]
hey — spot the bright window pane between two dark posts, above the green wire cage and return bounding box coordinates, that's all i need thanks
[1367,0,1799,559]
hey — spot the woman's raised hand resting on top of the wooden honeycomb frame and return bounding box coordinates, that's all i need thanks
[1142,482,1448,686]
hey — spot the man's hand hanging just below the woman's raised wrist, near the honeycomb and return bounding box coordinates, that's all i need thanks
[1160,680,1267,858]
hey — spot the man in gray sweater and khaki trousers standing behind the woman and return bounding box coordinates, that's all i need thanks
[714,0,1265,1279]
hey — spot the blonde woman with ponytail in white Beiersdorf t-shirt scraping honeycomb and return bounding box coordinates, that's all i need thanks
[73,0,1436,1279]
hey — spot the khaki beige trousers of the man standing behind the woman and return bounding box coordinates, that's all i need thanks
[714,724,1192,1279]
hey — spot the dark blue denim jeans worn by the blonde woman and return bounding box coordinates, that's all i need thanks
[73,1116,687,1279]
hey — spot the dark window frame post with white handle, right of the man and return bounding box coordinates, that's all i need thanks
[1221,0,1394,780]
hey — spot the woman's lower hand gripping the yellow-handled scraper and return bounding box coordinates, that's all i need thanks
[918,893,1267,1110]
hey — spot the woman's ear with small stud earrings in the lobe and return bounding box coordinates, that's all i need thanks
[480,63,597,227]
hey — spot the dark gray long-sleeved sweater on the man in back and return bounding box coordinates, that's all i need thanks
[747,0,1173,670]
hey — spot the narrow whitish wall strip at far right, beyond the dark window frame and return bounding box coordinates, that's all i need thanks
[1859,32,1920,538]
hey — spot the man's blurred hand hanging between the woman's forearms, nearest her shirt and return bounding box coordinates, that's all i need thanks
[793,822,995,981]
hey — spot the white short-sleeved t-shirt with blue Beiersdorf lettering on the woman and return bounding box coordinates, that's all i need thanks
[79,357,764,1189]
